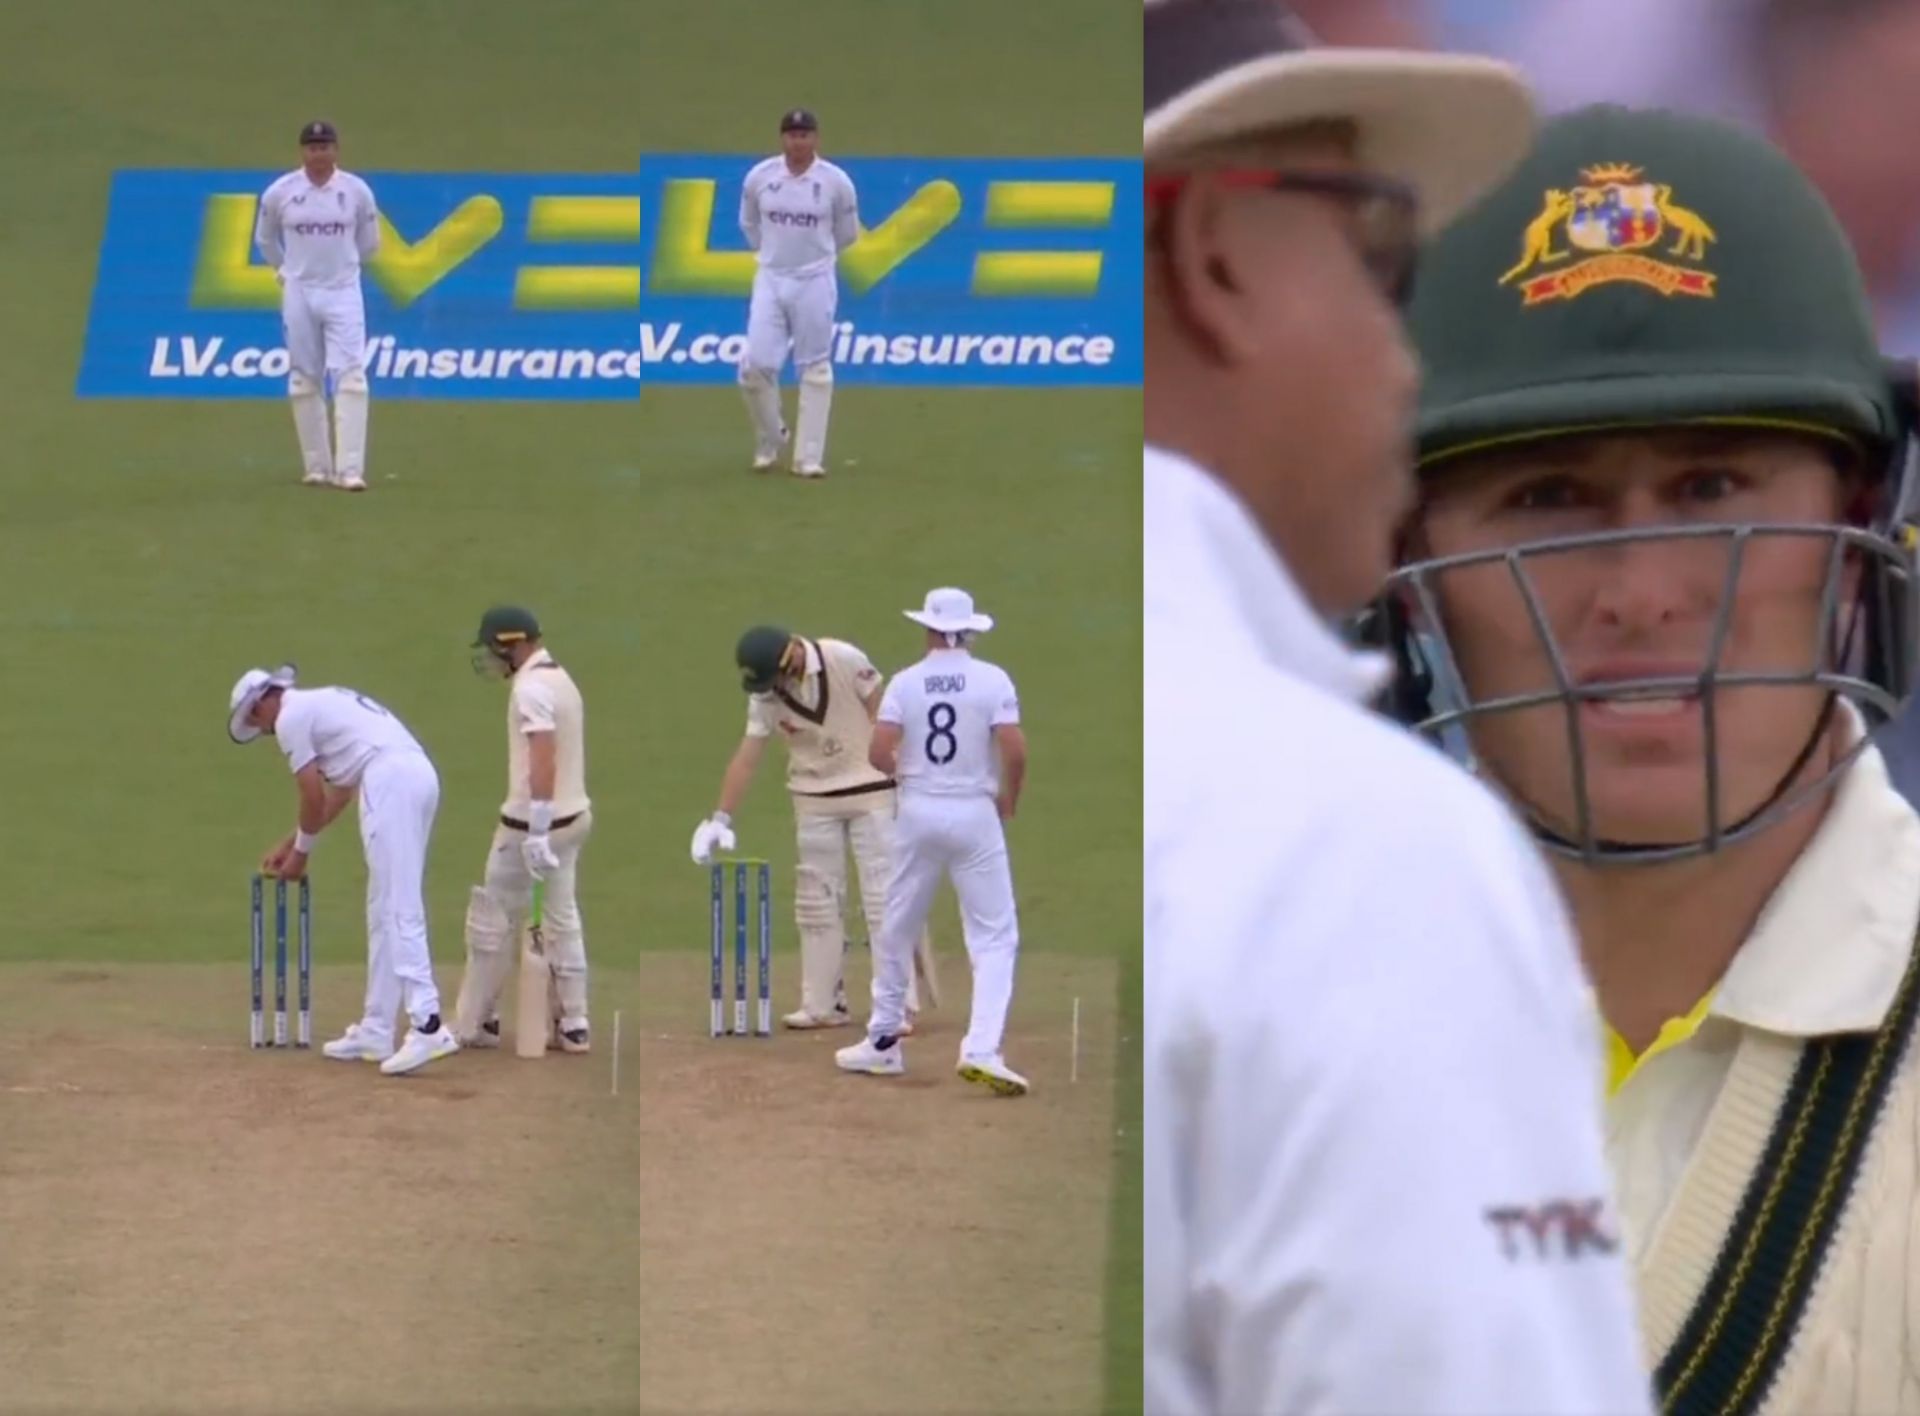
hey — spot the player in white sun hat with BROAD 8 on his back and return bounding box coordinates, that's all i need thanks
[833,587,1027,1096]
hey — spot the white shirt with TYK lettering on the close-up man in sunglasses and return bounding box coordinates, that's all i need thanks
[1142,449,1651,1416]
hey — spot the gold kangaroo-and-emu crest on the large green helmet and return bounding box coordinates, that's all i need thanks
[1500,163,1718,305]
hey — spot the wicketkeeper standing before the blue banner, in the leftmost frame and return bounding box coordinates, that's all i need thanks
[253,121,380,491]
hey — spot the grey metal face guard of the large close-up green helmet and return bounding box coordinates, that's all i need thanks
[1373,506,1920,865]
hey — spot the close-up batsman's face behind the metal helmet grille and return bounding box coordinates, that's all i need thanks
[1415,432,1857,844]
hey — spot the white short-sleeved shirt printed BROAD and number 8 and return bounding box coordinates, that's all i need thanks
[877,649,1020,796]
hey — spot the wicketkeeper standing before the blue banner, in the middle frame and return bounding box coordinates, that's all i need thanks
[739,107,860,478]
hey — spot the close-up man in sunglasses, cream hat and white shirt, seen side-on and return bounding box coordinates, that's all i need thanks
[1142,0,1651,1416]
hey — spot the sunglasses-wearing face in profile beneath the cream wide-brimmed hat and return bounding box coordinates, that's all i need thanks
[1146,125,1417,612]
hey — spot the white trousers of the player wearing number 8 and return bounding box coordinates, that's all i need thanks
[866,785,1020,1057]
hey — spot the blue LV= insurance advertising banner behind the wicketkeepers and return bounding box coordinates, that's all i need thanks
[77,153,1142,399]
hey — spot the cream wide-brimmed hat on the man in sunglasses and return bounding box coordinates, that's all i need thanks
[1144,0,1536,234]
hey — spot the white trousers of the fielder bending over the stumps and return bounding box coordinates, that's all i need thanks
[359,750,440,1042]
